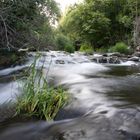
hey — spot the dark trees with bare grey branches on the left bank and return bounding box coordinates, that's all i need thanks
[0,0,60,50]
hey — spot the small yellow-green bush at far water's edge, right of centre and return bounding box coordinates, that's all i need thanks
[80,44,93,54]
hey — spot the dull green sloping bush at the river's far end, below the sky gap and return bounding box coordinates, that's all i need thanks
[56,34,75,53]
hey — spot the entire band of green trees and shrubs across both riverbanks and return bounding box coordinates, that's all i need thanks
[0,0,140,53]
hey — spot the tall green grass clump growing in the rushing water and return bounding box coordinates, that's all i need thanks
[15,58,68,120]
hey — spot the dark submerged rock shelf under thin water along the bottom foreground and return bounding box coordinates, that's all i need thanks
[0,109,140,140]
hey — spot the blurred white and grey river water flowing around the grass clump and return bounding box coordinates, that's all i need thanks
[0,51,140,140]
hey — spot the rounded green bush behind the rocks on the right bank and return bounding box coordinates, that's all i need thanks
[109,42,129,54]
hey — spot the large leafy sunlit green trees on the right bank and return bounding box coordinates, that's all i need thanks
[59,0,140,51]
